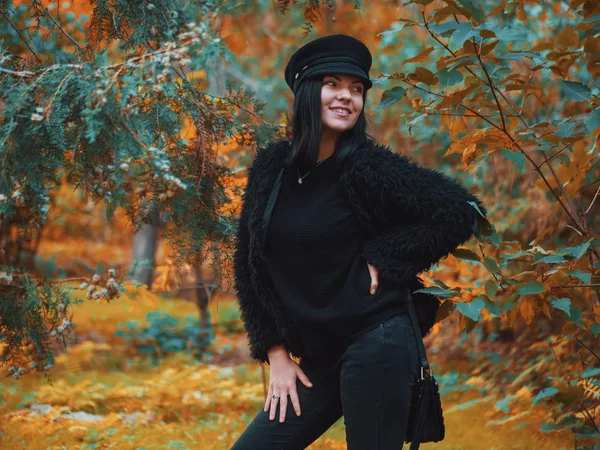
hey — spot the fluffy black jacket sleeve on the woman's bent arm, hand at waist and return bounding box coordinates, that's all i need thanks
[358,147,487,284]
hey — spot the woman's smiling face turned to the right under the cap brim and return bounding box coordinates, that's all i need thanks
[321,74,365,138]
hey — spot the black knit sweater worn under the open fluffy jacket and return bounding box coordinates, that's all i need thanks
[265,149,406,354]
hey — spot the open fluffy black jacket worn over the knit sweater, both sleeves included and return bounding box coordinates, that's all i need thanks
[234,140,487,362]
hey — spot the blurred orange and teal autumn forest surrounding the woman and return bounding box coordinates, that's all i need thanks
[0,0,600,450]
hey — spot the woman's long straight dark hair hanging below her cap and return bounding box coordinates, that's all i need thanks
[284,76,374,167]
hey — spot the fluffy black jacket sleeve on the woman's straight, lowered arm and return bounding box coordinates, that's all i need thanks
[233,149,284,363]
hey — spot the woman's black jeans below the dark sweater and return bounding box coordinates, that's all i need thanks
[231,313,420,450]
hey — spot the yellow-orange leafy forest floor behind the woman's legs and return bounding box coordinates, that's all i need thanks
[0,289,573,450]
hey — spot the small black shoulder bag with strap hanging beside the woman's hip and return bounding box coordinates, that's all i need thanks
[405,289,446,450]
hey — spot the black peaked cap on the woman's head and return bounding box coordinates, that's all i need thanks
[285,34,373,94]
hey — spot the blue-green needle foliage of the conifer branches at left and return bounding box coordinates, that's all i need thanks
[0,0,280,376]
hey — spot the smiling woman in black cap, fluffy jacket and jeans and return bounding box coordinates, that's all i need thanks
[233,35,486,450]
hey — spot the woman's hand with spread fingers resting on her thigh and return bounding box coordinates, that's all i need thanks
[264,353,313,423]
